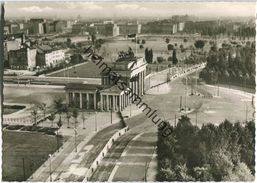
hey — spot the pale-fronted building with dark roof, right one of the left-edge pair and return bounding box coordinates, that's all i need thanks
[35,45,65,66]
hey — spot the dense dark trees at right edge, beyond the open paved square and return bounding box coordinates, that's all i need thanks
[200,42,256,87]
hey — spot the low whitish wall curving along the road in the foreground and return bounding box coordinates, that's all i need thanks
[83,127,128,182]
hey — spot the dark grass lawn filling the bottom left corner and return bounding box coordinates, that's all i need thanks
[2,131,62,181]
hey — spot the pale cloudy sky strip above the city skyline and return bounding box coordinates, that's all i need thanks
[5,2,256,18]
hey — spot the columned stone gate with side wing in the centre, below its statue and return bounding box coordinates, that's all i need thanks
[65,58,147,111]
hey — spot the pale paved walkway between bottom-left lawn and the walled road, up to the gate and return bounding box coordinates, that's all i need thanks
[28,105,141,181]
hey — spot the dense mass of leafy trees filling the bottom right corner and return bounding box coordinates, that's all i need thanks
[157,116,255,181]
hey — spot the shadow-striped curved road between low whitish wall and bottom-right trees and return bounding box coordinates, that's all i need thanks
[91,114,156,181]
